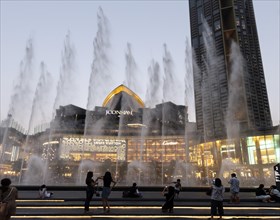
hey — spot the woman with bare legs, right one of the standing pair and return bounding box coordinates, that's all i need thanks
[96,171,117,213]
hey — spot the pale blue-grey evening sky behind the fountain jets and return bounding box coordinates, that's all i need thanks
[0,0,280,131]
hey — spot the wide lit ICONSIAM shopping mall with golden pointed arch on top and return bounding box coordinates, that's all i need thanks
[0,85,280,186]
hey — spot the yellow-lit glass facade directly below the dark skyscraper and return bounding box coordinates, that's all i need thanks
[186,134,280,184]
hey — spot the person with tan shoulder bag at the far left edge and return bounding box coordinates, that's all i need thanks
[0,178,18,220]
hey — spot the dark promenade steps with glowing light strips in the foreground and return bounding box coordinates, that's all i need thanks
[12,189,280,220]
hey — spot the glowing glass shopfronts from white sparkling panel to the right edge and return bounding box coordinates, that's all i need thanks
[51,132,280,185]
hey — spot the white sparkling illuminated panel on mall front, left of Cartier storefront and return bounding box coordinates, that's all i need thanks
[60,137,126,160]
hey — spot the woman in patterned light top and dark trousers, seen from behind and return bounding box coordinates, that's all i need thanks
[211,178,225,219]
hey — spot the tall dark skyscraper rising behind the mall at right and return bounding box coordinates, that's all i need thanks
[189,0,272,141]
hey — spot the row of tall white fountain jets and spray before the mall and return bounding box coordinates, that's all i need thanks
[1,8,278,186]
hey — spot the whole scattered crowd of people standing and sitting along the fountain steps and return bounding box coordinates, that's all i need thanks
[0,171,280,220]
